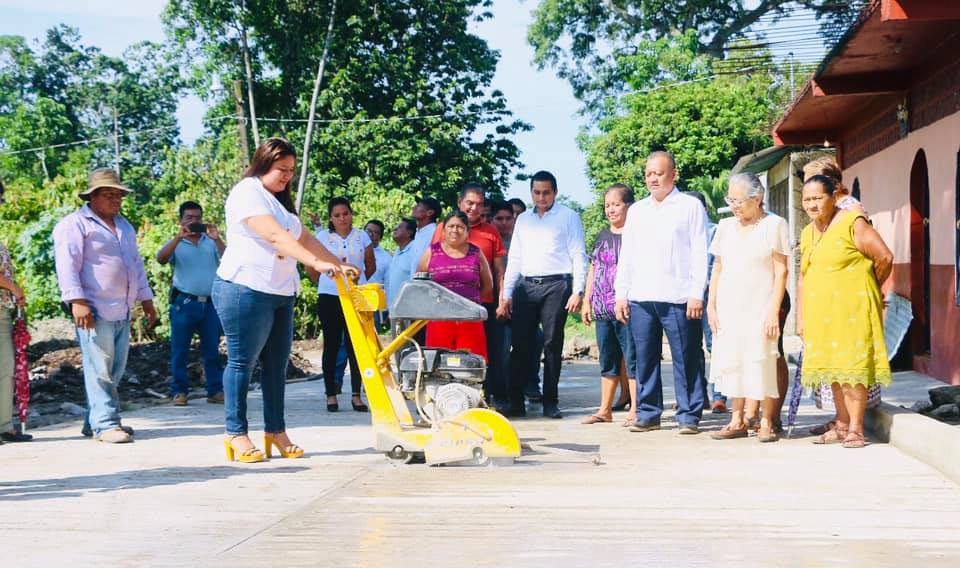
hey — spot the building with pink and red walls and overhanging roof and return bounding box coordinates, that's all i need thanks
[773,0,960,384]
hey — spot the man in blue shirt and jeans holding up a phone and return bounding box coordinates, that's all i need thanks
[157,201,226,406]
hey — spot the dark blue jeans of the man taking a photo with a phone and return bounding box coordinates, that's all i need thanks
[170,294,223,396]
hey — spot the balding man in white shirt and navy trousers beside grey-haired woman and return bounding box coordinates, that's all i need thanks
[614,152,707,434]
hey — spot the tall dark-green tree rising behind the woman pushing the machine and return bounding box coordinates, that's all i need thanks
[164,0,529,211]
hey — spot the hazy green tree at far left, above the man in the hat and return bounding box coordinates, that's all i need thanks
[0,25,182,186]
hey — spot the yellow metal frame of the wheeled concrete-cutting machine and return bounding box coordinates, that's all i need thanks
[334,276,520,465]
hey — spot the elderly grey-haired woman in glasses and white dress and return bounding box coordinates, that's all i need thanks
[707,173,790,442]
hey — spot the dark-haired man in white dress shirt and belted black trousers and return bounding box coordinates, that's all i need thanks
[497,171,587,418]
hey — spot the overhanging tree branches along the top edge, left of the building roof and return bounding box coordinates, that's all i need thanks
[527,0,868,113]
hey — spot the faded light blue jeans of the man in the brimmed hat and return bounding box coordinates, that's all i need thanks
[77,320,130,436]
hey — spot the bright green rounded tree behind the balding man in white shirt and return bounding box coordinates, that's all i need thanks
[580,32,789,223]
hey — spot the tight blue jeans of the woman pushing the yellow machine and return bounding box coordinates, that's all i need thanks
[212,278,294,436]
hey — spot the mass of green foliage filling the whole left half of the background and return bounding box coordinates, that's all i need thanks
[0,5,529,337]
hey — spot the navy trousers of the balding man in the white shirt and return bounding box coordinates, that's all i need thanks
[630,302,707,426]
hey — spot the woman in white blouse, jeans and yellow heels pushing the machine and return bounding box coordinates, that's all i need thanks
[212,138,357,462]
